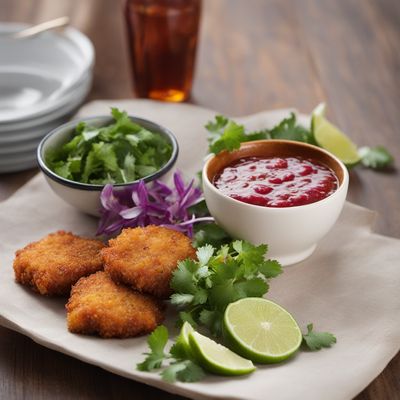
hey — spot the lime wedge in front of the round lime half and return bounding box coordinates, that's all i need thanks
[189,332,256,375]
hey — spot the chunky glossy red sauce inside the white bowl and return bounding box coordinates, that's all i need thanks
[213,157,338,207]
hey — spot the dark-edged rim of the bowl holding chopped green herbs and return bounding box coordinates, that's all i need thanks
[36,115,179,191]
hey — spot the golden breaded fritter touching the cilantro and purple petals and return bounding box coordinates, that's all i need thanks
[101,225,196,298]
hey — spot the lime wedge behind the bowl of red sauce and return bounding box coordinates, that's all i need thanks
[311,103,361,167]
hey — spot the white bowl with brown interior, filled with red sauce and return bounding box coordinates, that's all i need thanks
[203,140,349,265]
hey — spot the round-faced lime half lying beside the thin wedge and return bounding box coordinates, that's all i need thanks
[224,297,302,363]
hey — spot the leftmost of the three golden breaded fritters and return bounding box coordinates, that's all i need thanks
[14,231,104,295]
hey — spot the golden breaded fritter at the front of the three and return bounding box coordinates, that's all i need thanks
[66,271,164,338]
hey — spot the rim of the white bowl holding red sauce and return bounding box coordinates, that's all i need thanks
[202,139,349,213]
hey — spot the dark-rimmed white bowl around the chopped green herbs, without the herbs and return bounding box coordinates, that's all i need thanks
[37,116,179,217]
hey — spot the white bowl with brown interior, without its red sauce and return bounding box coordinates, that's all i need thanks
[203,140,349,266]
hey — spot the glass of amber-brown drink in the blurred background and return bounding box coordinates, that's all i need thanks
[125,0,201,102]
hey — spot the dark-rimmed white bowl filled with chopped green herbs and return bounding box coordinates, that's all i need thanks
[37,108,178,217]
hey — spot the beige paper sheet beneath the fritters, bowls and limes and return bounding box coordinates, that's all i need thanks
[0,100,400,400]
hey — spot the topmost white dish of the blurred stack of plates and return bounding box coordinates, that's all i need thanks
[0,23,94,124]
